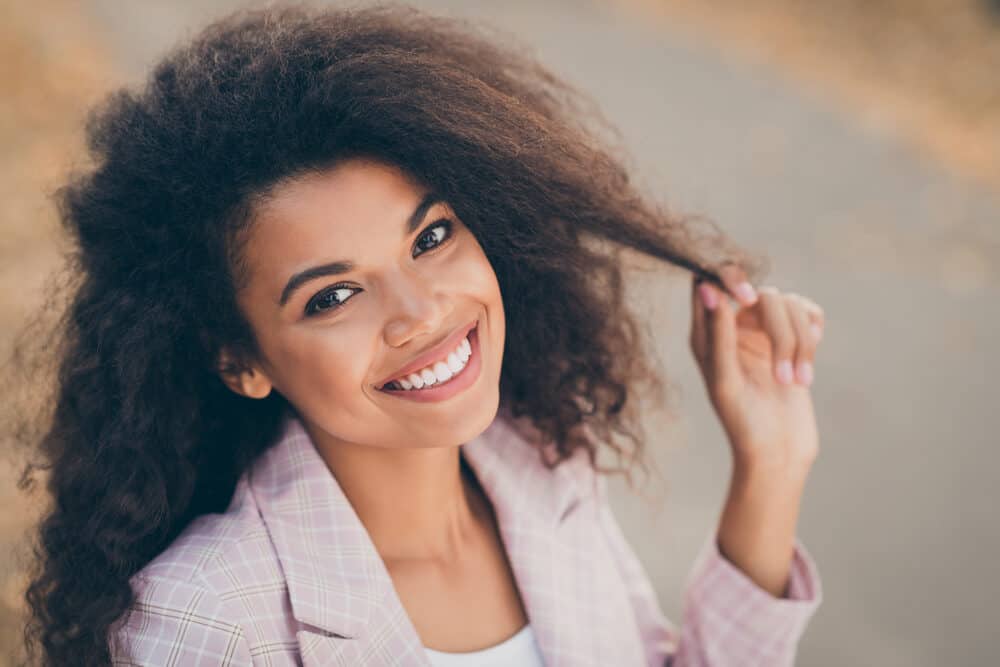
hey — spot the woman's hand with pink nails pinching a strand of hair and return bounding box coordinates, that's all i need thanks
[690,264,824,472]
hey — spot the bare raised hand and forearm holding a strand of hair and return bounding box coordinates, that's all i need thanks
[689,266,824,597]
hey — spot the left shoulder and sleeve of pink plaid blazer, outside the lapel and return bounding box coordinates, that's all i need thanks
[111,479,294,665]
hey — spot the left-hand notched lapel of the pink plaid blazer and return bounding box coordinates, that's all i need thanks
[250,415,430,667]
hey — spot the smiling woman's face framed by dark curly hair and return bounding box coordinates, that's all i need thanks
[227,158,505,448]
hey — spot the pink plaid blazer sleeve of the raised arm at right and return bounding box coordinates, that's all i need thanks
[598,475,823,667]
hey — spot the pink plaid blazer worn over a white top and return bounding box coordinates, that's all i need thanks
[109,409,822,667]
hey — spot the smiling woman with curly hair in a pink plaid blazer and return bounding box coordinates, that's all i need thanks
[17,2,822,666]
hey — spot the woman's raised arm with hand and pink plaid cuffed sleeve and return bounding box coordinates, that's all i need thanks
[676,272,824,665]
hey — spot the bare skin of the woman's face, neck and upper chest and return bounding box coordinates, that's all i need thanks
[218,159,526,651]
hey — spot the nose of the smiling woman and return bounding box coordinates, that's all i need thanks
[384,272,447,347]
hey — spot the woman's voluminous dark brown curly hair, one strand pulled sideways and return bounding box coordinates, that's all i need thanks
[12,4,761,665]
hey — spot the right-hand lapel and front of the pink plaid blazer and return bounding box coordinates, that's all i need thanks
[462,409,645,667]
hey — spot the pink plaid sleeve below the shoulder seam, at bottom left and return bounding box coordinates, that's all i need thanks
[108,576,252,667]
